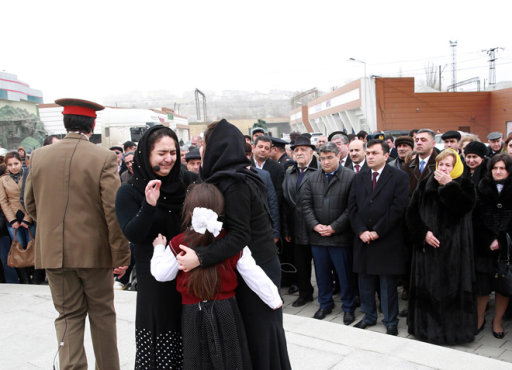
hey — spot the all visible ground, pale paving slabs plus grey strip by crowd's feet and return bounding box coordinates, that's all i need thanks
[0,284,512,370]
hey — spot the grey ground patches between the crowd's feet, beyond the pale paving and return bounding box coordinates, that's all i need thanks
[281,288,512,369]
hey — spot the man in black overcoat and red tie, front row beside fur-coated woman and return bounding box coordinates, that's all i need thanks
[349,140,409,335]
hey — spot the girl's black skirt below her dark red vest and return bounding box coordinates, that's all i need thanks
[181,297,251,370]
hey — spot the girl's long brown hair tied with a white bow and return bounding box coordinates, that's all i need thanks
[183,182,224,300]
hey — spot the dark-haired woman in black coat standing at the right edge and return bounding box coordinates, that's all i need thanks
[474,153,512,339]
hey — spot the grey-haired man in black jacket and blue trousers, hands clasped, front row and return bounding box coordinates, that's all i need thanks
[302,143,355,325]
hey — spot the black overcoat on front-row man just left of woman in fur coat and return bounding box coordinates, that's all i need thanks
[349,165,409,275]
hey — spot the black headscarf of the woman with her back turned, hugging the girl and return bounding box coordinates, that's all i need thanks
[199,119,265,193]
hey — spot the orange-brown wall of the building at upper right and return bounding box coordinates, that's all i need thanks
[375,78,494,139]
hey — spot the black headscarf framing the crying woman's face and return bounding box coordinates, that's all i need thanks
[128,125,186,210]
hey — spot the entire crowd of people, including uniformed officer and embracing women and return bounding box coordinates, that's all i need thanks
[0,99,512,369]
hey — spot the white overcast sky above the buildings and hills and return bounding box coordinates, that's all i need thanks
[4,0,512,103]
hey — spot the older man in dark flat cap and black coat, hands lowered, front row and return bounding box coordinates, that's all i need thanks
[283,135,318,307]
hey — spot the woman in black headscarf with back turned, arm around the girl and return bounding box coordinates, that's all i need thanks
[177,120,291,370]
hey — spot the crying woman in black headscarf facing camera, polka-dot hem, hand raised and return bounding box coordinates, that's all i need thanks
[116,125,194,369]
